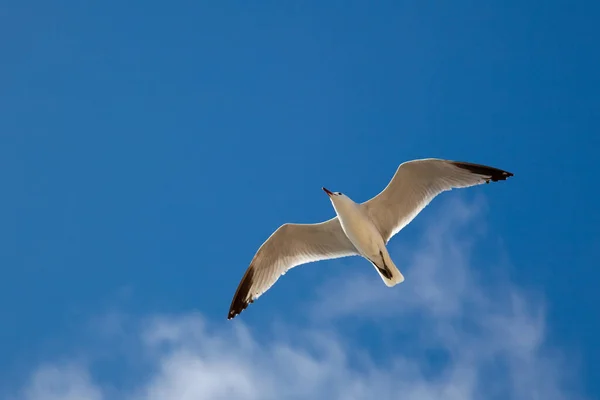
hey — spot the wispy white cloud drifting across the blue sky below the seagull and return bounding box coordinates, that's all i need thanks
[11,197,588,400]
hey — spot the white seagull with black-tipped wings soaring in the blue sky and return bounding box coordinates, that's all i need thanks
[227,158,513,319]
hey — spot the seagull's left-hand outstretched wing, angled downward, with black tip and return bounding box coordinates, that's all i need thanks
[227,217,358,319]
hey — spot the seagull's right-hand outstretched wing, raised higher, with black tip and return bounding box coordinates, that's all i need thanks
[362,158,513,242]
